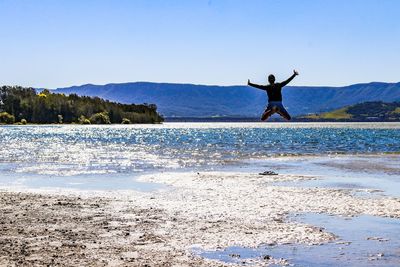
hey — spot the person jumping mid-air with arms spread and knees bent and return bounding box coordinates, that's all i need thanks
[247,70,299,121]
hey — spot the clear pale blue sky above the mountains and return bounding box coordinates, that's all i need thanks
[0,0,400,88]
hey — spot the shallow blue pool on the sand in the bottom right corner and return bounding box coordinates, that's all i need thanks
[196,213,400,267]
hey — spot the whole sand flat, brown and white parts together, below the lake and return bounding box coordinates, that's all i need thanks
[0,172,400,266]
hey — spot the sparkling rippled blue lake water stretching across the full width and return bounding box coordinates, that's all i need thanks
[0,123,400,176]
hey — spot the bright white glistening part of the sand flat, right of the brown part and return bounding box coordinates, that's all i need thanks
[141,172,400,249]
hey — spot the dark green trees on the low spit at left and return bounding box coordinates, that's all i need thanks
[0,86,164,124]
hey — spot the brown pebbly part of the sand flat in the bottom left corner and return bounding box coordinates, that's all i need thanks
[0,192,216,266]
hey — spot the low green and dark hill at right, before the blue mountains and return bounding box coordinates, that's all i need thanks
[296,102,400,121]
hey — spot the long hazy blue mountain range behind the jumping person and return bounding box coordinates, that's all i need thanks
[51,82,400,118]
